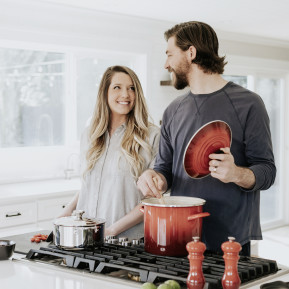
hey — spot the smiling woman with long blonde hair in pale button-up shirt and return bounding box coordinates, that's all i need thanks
[62,66,160,238]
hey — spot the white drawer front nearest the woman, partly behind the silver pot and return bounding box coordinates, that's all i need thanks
[38,195,73,221]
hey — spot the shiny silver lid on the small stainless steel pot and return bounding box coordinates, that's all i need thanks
[54,210,105,227]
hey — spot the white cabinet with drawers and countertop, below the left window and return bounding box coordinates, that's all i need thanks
[0,179,81,236]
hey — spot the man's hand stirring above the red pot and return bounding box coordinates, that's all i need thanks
[137,169,167,198]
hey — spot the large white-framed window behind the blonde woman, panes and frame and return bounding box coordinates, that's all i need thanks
[0,42,146,183]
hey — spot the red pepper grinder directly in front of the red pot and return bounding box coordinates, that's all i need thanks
[186,237,206,289]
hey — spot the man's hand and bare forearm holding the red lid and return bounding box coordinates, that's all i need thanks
[209,147,256,189]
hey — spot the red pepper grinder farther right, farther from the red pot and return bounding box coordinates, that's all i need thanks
[222,237,242,289]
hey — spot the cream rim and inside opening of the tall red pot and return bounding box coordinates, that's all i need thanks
[142,196,206,207]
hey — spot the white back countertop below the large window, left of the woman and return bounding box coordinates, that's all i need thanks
[0,178,81,202]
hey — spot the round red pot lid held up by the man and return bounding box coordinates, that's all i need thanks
[183,120,232,179]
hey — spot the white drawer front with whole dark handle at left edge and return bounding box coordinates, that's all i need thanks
[0,202,37,228]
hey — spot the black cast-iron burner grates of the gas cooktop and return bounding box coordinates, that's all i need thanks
[26,243,278,289]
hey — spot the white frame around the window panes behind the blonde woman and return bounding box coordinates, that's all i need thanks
[0,40,147,185]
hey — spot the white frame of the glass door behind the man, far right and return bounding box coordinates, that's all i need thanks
[224,56,289,230]
